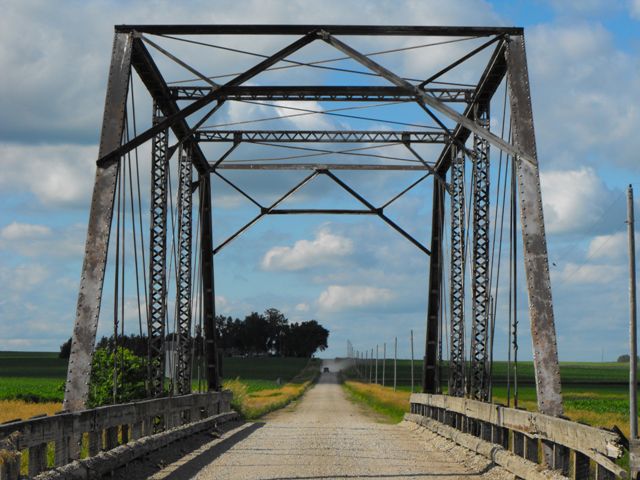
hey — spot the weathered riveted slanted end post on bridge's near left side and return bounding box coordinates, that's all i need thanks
[62,33,132,411]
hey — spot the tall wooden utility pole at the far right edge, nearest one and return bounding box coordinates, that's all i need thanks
[627,185,638,440]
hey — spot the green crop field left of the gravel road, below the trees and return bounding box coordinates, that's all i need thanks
[0,352,316,402]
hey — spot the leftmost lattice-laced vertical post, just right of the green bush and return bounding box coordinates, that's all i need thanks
[147,104,169,397]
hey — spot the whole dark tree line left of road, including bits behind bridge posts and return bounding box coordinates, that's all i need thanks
[59,308,329,358]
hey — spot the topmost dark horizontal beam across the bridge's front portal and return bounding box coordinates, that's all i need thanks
[115,24,523,37]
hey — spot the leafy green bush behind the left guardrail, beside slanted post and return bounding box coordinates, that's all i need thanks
[88,347,147,408]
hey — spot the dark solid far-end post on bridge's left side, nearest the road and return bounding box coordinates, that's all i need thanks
[198,173,220,390]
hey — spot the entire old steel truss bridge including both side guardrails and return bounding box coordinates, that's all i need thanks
[0,25,623,478]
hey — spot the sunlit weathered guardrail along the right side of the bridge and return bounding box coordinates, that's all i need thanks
[406,393,627,480]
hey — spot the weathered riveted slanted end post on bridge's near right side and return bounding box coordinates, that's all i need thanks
[506,35,562,416]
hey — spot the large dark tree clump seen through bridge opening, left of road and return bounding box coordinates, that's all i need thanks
[216,308,329,358]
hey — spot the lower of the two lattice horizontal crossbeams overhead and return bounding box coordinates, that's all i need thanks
[195,130,447,143]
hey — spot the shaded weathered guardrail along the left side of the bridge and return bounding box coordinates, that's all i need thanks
[0,391,232,480]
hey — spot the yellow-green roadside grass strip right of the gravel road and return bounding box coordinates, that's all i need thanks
[342,380,411,423]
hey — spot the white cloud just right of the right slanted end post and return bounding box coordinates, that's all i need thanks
[540,167,615,233]
